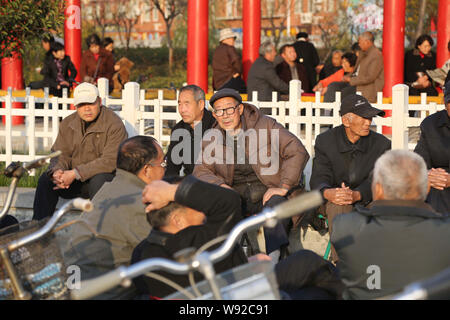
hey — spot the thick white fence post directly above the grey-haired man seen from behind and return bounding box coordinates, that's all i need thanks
[392,84,409,150]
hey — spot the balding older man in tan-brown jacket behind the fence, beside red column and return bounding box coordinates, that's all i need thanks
[342,31,384,103]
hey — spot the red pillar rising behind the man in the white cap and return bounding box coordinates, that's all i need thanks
[64,0,81,81]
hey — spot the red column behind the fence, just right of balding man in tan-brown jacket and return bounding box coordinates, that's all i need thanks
[383,0,406,134]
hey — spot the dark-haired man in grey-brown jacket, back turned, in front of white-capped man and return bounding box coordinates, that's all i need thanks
[65,136,166,299]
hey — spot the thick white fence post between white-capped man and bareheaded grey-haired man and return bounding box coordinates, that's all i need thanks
[121,82,139,137]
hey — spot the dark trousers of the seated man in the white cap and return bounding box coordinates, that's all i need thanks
[33,173,114,220]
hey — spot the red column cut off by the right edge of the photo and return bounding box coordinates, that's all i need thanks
[436,0,450,68]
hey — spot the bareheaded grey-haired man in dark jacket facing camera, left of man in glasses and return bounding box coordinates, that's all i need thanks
[166,85,216,176]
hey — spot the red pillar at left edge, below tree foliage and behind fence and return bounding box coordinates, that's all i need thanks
[1,52,25,125]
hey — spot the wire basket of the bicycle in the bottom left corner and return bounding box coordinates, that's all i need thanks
[0,219,69,300]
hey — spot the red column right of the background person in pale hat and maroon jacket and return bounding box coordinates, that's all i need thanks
[242,0,261,81]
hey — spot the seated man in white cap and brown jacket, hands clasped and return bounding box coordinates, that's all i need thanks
[33,82,128,220]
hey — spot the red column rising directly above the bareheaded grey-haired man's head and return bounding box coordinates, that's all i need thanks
[187,0,209,93]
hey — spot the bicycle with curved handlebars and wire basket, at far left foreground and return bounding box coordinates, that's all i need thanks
[0,151,92,300]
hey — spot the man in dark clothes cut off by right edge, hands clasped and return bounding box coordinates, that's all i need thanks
[414,81,450,213]
